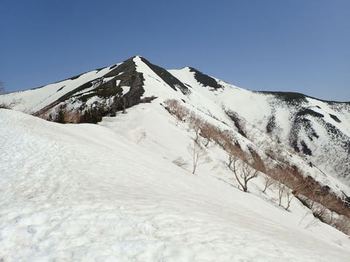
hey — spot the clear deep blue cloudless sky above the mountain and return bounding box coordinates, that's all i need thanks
[0,0,350,101]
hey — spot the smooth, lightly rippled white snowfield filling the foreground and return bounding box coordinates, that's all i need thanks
[0,109,350,262]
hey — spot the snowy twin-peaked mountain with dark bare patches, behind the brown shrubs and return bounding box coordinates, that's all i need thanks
[0,57,350,192]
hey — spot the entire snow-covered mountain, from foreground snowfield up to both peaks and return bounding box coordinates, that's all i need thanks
[0,56,350,261]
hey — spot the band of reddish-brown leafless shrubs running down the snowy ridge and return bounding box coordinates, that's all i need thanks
[165,100,350,234]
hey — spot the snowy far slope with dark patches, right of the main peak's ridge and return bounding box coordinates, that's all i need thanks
[169,67,350,188]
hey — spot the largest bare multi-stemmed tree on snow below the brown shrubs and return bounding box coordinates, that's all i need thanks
[228,153,258,192]
